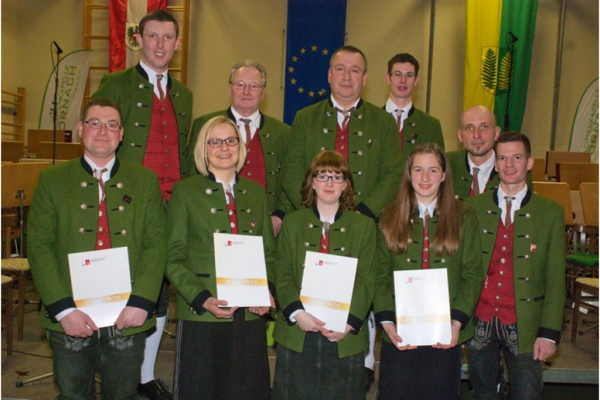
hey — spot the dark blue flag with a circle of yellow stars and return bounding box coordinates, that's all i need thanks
[283,0,346,125]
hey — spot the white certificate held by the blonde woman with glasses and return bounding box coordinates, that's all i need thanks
[214,233,271,307]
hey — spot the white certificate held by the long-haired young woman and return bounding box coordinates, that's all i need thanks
[394,268,452,346]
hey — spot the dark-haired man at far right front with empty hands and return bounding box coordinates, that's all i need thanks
[467,132,565,400]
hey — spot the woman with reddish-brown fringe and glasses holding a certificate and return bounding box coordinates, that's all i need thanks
[273,150,377,400]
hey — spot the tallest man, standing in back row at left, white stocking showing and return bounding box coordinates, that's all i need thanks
[94,10,193,400]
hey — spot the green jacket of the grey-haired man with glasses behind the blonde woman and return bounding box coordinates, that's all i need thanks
[188,108,294,219]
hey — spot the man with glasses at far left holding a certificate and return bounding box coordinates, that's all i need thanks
[28,98,166,399]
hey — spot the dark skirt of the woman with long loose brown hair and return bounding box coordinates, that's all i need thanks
[377,341,460,400]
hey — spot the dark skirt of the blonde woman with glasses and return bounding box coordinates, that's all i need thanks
[173,308,271,400]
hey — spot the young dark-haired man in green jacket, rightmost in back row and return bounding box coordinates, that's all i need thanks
[384,53,444,163]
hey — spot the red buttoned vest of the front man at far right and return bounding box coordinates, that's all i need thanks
[475,221,517,325]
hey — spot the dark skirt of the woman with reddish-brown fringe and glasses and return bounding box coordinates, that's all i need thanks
[273,332,366,400]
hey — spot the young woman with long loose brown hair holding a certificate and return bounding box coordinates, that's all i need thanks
[374,143,483,400]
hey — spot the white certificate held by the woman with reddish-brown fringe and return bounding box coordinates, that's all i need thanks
[300,251,358,332]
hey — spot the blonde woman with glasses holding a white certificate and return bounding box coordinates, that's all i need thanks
[166,116,275,399]
